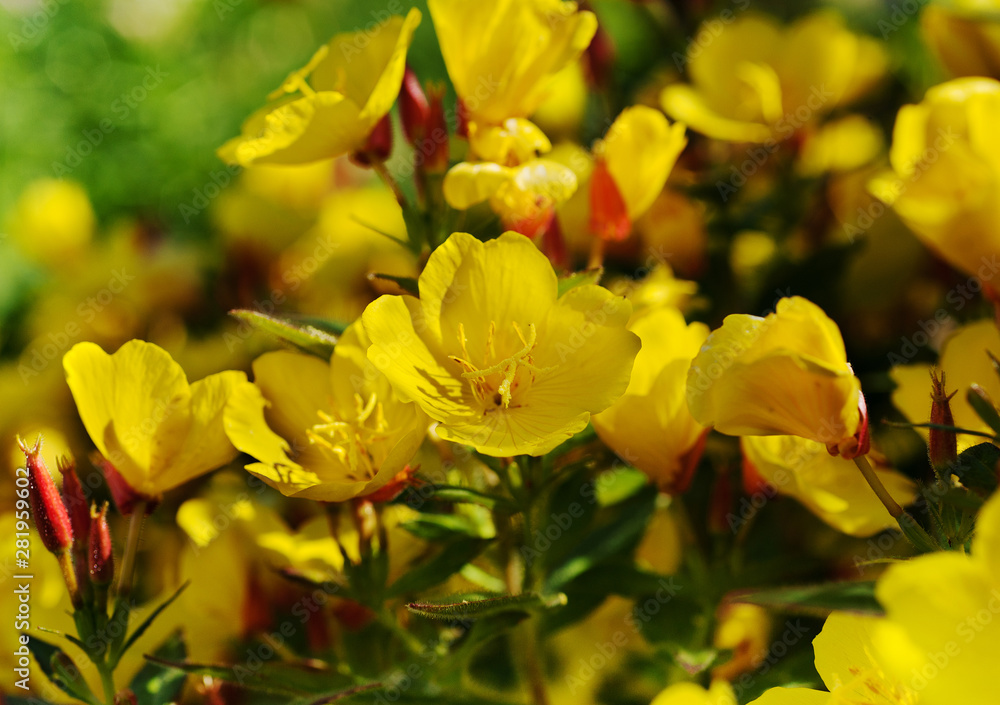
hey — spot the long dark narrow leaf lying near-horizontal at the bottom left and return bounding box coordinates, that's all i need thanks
[146,656,354,697]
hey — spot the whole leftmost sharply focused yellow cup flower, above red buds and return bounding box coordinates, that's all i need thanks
[63,340,246,498]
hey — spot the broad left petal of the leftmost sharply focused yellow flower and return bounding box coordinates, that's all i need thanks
[63,340,191,496]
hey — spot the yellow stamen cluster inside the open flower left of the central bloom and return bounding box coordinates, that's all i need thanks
[306,394,390,481]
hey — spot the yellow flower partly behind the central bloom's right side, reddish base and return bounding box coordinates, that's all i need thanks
[593,308,708,492]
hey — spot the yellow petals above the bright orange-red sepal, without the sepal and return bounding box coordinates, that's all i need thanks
[603,105,687,220]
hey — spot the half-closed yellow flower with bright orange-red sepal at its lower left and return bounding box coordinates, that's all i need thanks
[590,105,687,240]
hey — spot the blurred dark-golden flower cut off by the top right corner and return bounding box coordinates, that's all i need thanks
[920,0,1000,79]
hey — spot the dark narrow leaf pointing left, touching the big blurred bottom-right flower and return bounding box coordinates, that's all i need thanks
[727,581,885,617]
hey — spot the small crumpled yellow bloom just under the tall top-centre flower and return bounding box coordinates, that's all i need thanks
[443,159,576,235]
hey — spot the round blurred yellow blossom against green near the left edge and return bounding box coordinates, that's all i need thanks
[6,179,96,267]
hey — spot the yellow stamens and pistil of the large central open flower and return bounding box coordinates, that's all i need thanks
[448,321,554,412]
